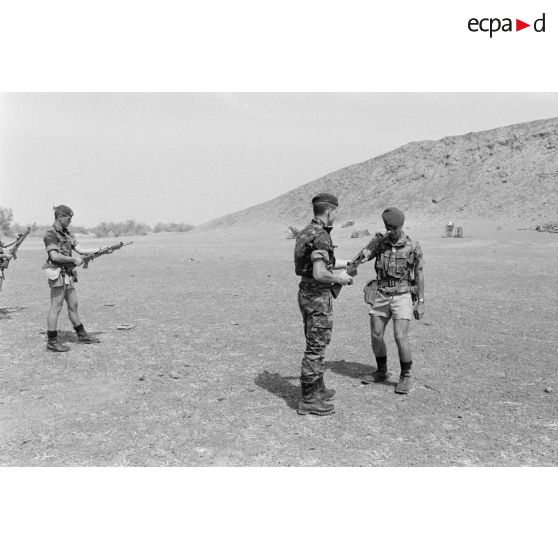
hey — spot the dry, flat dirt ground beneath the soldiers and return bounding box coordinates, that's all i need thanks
[0,222,558,466]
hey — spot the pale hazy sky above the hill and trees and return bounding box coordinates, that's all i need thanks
[0,93,558,226]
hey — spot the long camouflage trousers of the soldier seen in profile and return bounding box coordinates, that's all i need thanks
[298,283,333,382]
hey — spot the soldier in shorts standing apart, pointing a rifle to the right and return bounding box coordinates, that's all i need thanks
[43,205,106,353]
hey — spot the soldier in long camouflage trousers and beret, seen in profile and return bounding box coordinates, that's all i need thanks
[294,193,352,415]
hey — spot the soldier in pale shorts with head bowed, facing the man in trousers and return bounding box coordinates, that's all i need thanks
[363,207,424,394]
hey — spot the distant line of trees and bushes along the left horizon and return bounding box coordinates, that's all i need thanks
[0,207,194,238]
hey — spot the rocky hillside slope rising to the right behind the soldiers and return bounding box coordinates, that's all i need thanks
[199,118,558,229]
